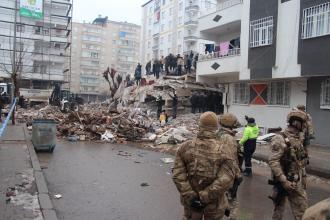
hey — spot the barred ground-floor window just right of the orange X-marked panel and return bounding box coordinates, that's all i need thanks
[268,81,290,106]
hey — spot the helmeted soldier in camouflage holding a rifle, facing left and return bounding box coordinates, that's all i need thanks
[269,111,308,220]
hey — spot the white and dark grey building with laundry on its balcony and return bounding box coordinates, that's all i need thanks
[197,0,330,145]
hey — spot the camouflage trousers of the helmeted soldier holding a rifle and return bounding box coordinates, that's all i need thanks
[273,184,308,220]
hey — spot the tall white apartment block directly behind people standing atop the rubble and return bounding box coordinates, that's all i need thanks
[141,0,214,72]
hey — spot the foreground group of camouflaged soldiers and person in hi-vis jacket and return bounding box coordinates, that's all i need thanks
[173,106,316,220]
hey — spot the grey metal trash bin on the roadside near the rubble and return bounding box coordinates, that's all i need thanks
[32,119,57,152]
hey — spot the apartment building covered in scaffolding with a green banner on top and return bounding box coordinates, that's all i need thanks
[0,0,72,100]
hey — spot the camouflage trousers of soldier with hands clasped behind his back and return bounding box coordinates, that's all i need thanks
[183,204,225,220]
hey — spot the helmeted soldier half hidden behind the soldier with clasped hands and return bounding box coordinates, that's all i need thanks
[218,113,244,220]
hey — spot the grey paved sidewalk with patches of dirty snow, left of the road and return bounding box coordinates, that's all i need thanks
[0,125,57,220]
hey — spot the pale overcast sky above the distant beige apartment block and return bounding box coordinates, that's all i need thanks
[73,0,147,24]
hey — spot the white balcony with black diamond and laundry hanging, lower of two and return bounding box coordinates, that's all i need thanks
[197,48,241,76]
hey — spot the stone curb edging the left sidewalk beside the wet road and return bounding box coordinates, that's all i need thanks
[24,127,58,220]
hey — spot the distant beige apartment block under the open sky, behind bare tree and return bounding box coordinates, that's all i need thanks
[71,17,140,101]
